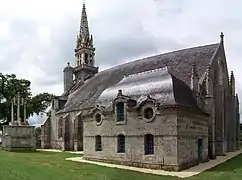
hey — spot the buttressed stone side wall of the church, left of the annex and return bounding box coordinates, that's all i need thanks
[41,104,83,151]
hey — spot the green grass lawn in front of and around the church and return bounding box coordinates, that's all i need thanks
[0,151,242,180]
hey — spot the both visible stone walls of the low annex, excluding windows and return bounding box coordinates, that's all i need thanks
[84,108,209,171]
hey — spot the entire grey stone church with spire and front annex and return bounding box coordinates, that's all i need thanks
[41,4,240,171]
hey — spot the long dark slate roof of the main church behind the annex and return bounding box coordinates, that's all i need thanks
[58,43,220,113]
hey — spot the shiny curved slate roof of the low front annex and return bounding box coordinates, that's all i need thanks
[97,67,198,109]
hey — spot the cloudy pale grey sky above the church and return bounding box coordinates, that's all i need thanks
[0,0,242,124]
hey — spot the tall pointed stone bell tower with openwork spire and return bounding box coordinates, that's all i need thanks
[74,1,98,81]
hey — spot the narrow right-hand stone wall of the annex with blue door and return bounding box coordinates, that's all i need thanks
[177,110,210,169]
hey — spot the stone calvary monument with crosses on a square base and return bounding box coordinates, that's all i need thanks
[2,93,36,151]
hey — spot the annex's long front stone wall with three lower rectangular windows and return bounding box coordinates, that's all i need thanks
[84,109,177,166]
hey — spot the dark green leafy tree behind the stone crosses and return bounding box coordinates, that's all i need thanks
[0,74,53,128]
